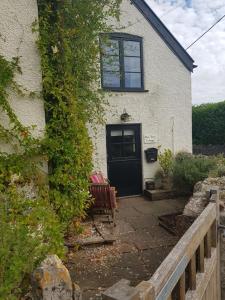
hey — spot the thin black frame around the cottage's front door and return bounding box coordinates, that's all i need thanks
[105,123,144,198]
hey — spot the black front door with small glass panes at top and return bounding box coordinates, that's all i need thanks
[106,124,142,196]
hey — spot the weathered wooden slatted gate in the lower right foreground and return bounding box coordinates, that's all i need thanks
[103,193,221,300]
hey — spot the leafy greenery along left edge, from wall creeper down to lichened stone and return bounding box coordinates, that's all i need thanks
[0,56,64,300]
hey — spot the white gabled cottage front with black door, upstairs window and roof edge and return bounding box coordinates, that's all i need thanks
[89,0,195,196]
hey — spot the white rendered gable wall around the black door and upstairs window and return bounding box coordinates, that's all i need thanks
[92,0,192,183]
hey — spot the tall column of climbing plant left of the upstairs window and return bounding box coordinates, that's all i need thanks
[38,0,121,222]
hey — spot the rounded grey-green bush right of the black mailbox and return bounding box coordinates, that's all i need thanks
[172,153,216,192]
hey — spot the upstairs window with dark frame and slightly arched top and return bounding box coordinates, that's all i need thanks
[101,34,144,91]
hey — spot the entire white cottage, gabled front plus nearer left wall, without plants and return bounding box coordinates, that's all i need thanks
[0,0,195,196]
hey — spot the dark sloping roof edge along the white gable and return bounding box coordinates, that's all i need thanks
[131,0,194,72]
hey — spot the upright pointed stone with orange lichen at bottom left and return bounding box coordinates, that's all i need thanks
[32,255,73,300]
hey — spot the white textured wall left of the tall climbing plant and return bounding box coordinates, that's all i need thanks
[0,0,45,150]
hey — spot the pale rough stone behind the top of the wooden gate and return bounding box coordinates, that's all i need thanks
[183,177,225,217]
